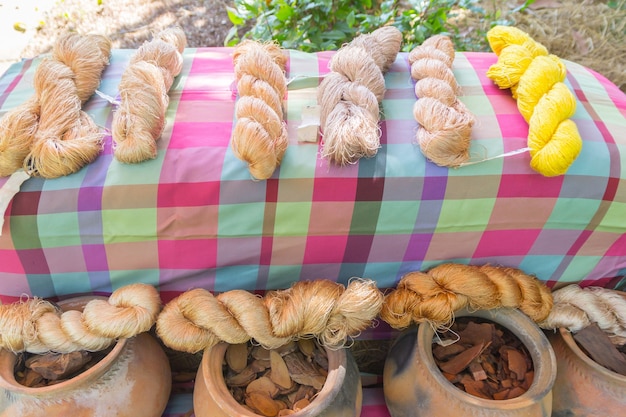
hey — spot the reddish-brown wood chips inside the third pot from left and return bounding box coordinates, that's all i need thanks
[433,317,534,400]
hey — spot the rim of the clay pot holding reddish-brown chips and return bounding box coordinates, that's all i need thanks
[417,308,556,409]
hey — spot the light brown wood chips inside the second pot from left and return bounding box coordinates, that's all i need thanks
[224,339,328,417]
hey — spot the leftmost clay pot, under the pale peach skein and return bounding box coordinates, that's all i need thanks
[0,297,172,417]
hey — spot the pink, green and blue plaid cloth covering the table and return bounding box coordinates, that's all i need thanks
[0,48,626,302]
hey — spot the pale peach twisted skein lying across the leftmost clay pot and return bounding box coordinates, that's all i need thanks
[0,284,161,353]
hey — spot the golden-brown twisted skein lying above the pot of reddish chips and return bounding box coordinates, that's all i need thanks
[380,264,553,329]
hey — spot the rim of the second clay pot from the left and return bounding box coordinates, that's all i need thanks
[200,342,347,417]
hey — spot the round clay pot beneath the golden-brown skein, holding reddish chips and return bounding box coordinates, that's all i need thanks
[383,309,556,417]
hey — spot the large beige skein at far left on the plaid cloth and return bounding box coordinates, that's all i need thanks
[0,33,111,178]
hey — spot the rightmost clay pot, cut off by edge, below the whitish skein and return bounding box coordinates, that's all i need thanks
[548,329,626,417]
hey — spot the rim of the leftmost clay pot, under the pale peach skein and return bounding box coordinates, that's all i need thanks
[0,296,128,396]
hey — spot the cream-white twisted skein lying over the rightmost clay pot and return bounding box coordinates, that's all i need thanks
[539,284,626,337]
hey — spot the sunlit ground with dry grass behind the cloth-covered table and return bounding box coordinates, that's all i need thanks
[0,0,626,91]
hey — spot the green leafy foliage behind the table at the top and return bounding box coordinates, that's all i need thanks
[224,0,534,52]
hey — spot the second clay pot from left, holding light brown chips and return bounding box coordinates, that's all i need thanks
[193,343,363,417]
